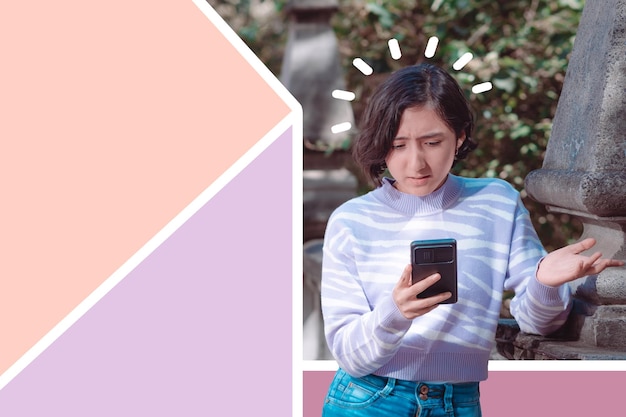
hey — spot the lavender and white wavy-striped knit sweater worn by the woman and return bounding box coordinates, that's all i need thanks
[322,174,571,382]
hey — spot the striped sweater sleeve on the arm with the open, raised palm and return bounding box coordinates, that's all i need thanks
[505,195,572,336]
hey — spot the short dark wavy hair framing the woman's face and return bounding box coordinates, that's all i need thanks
[352,63,477,186]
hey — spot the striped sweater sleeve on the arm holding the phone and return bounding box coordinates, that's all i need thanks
[321,210,411,377]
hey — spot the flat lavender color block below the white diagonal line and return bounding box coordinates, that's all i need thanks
[0,130,293,417]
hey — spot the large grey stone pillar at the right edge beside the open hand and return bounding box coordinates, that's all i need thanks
[526,0,626,353]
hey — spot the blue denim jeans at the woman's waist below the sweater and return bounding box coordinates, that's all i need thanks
[322,369,482,417]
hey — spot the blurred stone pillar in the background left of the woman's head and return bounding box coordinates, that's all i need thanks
[280,0,357,241]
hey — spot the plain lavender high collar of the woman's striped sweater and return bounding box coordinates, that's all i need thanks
[373,174,463,215]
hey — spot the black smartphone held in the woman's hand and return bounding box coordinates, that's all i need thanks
[411,239,457,304]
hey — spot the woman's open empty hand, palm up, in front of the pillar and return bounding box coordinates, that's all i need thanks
[537,238,624,287]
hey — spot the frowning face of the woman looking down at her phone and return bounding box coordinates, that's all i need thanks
[385,106,465,196]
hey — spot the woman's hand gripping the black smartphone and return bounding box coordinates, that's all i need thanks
[392,264,452,320]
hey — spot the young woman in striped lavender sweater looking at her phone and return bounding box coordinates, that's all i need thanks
[322,64,623,417]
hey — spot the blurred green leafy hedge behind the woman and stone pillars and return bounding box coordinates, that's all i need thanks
[209,0,584,250]
